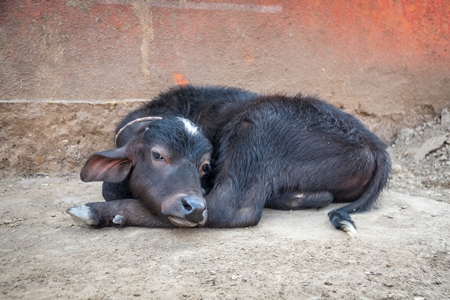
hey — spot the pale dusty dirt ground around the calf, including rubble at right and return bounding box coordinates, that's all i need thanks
[0,113,450,300]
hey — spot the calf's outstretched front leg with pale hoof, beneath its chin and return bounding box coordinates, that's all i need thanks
[66,199,173,228]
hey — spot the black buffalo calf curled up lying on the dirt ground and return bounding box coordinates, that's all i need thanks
[67,86,391,235]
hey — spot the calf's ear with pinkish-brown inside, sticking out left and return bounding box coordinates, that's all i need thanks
[80,147,133,182]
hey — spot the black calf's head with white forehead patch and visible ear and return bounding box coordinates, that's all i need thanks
[81,117,212,227]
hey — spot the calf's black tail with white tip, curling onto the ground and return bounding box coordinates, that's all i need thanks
[328,149,391,236]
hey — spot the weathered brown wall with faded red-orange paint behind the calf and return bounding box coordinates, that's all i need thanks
[0,0,450,177]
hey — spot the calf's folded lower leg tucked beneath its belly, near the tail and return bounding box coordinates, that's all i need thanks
[266,192,333,210]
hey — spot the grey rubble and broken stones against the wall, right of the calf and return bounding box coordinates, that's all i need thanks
[389,108,450,203]
